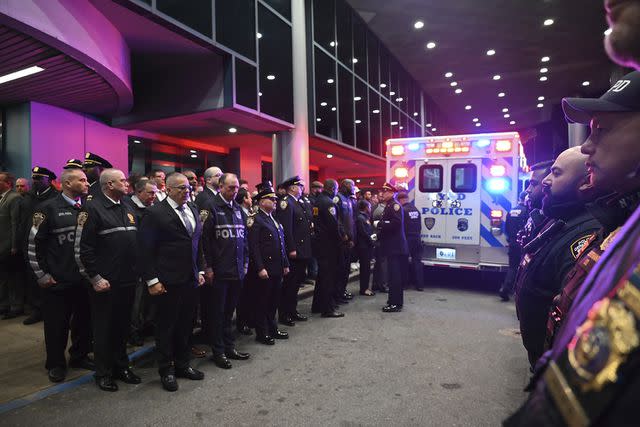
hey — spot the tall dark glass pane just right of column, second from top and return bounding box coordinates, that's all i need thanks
[314,47,338,139]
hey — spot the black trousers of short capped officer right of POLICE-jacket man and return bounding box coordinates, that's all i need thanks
[251,273,282,337]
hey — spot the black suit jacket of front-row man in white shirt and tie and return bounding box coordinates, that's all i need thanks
[138,199,204,286]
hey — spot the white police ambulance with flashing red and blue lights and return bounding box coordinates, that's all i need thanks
[386,132,528,271]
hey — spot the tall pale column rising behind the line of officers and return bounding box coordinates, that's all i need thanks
[272,0,309,185]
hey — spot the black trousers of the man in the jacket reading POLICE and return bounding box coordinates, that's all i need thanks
[209,279,242,354]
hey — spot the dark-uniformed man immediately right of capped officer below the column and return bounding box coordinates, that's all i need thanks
[311,179,348,318]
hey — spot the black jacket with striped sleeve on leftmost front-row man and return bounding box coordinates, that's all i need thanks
[27,194,84,290]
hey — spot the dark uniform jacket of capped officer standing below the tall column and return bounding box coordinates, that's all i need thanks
[275,194,313,259]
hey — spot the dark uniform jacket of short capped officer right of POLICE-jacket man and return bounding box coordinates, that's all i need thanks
[247,210,289,277]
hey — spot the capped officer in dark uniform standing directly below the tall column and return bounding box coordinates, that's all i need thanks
[275,176,313,326]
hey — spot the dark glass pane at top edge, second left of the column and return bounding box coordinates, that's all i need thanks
[215,0,257,60]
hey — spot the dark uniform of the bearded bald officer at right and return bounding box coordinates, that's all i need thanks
[516,202,598,367]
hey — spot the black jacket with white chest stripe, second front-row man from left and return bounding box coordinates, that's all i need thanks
[74,192,138,286]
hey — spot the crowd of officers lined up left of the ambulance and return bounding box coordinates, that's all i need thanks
[0,153,422,391]
